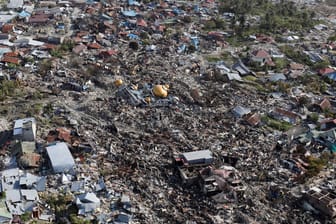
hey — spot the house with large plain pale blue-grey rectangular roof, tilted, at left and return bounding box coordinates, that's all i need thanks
[47,142,75,173]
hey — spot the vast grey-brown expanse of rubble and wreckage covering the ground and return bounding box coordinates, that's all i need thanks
[0,1,336,224]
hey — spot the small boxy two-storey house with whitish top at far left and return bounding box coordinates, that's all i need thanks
[13,117,36,141]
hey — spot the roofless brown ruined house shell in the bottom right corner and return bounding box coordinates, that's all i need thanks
[304,188,336,217]
